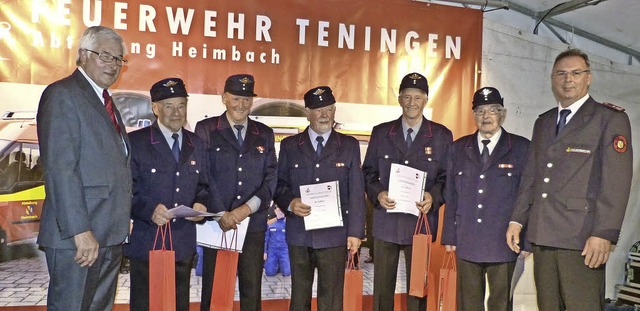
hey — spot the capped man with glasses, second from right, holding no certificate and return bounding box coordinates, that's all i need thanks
[442,87,529,311]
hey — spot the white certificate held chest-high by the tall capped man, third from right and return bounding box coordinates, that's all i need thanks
[387,163,427,216]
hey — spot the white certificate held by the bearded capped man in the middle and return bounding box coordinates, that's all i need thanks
[300,180,343,231]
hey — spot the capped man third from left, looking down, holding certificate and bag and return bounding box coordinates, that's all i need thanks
[195,74,277,311]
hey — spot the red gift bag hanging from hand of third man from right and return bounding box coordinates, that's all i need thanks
[409,213,431,297]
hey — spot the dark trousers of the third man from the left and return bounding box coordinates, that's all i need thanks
[200,231,264,311]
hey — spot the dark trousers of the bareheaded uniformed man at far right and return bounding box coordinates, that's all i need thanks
[533,245,605,311]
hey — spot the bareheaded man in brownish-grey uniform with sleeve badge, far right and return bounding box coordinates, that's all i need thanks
[506,49,633,311]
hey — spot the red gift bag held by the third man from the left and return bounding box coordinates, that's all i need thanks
[209,230,240,311]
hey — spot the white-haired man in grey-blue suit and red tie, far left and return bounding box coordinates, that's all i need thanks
[37,26,131,310]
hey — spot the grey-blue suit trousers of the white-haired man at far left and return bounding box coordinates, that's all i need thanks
[44,245,122,311]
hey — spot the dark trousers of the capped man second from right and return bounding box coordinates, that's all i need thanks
[456,258,516,311]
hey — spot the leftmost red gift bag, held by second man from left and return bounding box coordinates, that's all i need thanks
[149,223,176,311]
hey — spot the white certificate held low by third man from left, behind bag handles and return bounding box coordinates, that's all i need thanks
[196,217,251,253]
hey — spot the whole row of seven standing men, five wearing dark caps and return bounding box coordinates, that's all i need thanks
[38,26,632,311]
